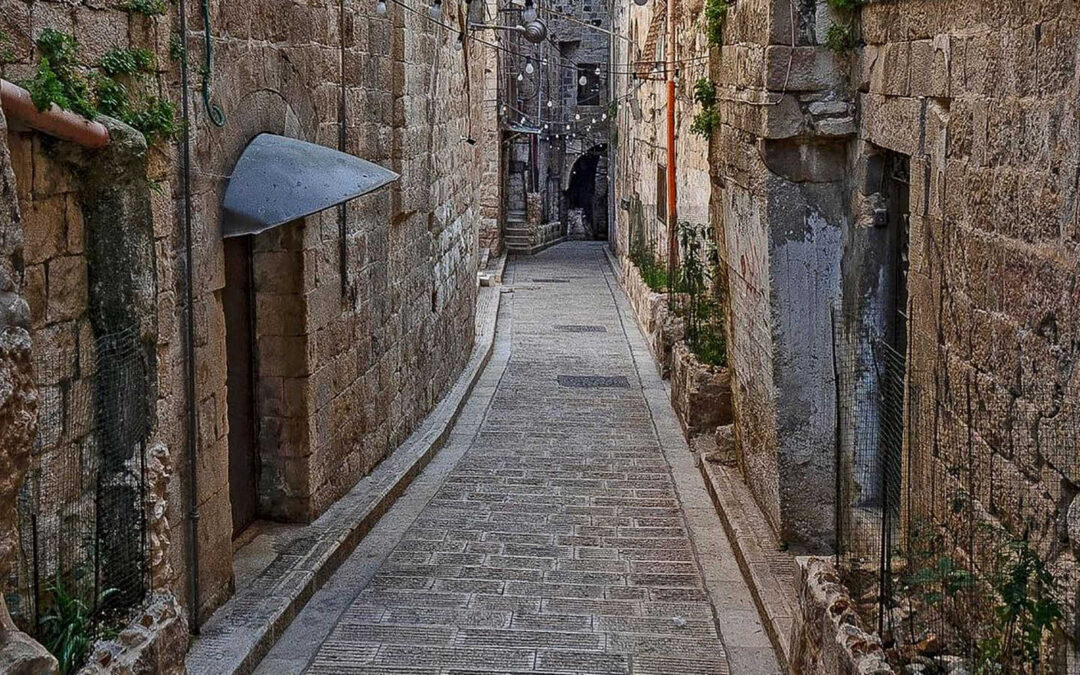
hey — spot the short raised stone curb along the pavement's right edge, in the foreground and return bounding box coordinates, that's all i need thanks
[698,459,798,671]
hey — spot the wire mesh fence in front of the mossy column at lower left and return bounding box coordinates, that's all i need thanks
[9,329,152,646]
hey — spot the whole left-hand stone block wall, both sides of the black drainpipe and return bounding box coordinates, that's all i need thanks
[0,0,500,648]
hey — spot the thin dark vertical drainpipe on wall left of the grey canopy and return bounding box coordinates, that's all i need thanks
[179,0,200,635]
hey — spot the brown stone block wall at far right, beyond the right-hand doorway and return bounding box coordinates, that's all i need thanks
[853,0,1080,626]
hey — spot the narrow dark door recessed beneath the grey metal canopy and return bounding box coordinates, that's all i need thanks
[222,237,259,537]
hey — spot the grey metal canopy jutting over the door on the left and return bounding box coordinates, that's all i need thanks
[221,134,401,238]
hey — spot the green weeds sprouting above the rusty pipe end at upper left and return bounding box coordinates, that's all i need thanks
[23,28,179,141]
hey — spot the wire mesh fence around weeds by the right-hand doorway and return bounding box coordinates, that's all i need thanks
[834,308,1080,674]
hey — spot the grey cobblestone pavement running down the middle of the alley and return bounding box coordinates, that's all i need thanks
[259,243,777,675]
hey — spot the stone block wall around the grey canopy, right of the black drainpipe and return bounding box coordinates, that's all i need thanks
[174,2,492,616]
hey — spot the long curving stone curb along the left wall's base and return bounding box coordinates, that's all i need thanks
[186,287,500,675]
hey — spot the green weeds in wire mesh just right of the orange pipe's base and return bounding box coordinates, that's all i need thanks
[676,222,728,366]
